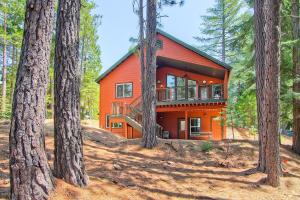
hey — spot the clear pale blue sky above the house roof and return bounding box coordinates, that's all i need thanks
[95,0,214,73]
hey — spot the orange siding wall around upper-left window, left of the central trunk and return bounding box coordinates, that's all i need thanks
[99,54,141,128]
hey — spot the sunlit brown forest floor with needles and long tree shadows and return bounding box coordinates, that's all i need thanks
[0,123,300,200]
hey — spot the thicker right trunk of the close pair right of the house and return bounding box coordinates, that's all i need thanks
[264,0,281,187]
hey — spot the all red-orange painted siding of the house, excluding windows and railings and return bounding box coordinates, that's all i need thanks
[99,34,230,140]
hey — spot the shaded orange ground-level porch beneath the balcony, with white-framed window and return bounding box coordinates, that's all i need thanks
[157,107,226,140]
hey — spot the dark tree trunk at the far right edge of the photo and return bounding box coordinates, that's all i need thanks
[292,0,300,154]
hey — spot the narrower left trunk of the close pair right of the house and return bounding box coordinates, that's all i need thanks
[254,0,266,172]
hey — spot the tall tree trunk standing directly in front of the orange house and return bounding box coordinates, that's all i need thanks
[142,0,157,148]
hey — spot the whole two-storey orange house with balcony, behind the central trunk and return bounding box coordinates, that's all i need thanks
[97,30,231,140]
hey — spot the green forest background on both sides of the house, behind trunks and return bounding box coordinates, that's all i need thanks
[0,0,296,133]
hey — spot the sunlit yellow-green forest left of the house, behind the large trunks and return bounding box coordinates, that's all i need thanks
[0,0,101,119]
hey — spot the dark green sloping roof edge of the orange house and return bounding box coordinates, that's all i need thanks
[96,29,232,83]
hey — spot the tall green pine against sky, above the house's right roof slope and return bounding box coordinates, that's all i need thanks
[195,0,243,62]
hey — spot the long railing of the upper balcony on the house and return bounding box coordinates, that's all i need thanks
[157,84,225,102]
